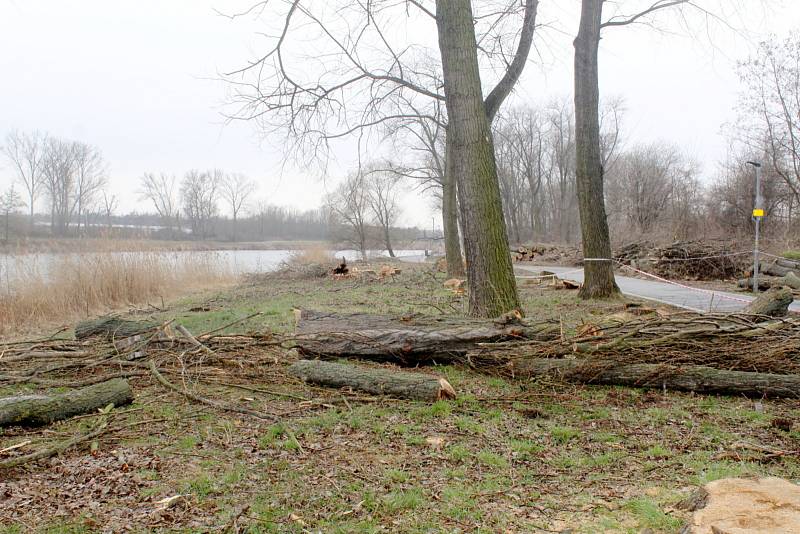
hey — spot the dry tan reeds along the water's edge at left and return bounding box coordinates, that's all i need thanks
[0,251,234,335]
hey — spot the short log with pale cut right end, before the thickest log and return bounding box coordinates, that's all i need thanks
[289,360,456,402]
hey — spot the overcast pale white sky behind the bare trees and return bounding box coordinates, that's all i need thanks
[0,0,800,226]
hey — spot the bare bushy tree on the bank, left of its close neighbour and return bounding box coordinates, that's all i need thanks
[326,172,371,259]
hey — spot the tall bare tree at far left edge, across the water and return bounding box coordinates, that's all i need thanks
[1,131,47,228]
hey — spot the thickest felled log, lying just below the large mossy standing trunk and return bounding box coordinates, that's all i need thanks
[294,310,559,365]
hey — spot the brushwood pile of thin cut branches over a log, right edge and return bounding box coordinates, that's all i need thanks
[467,312,800,397]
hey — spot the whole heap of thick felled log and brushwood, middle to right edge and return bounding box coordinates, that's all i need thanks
[296,300,800,397]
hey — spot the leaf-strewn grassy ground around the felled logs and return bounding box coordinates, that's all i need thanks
[0,269,800,533]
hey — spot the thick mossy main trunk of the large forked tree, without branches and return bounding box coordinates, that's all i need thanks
[436,0,520,317]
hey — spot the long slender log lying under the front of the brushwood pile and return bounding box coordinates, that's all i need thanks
[514,359,800,397]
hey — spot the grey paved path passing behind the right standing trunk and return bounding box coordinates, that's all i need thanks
[514,264,800,312]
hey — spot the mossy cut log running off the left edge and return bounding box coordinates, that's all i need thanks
[0,378,133,427]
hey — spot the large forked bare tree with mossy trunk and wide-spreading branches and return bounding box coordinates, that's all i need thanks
[222,0,538,316]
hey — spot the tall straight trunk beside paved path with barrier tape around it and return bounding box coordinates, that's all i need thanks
[575,0,619,298]
